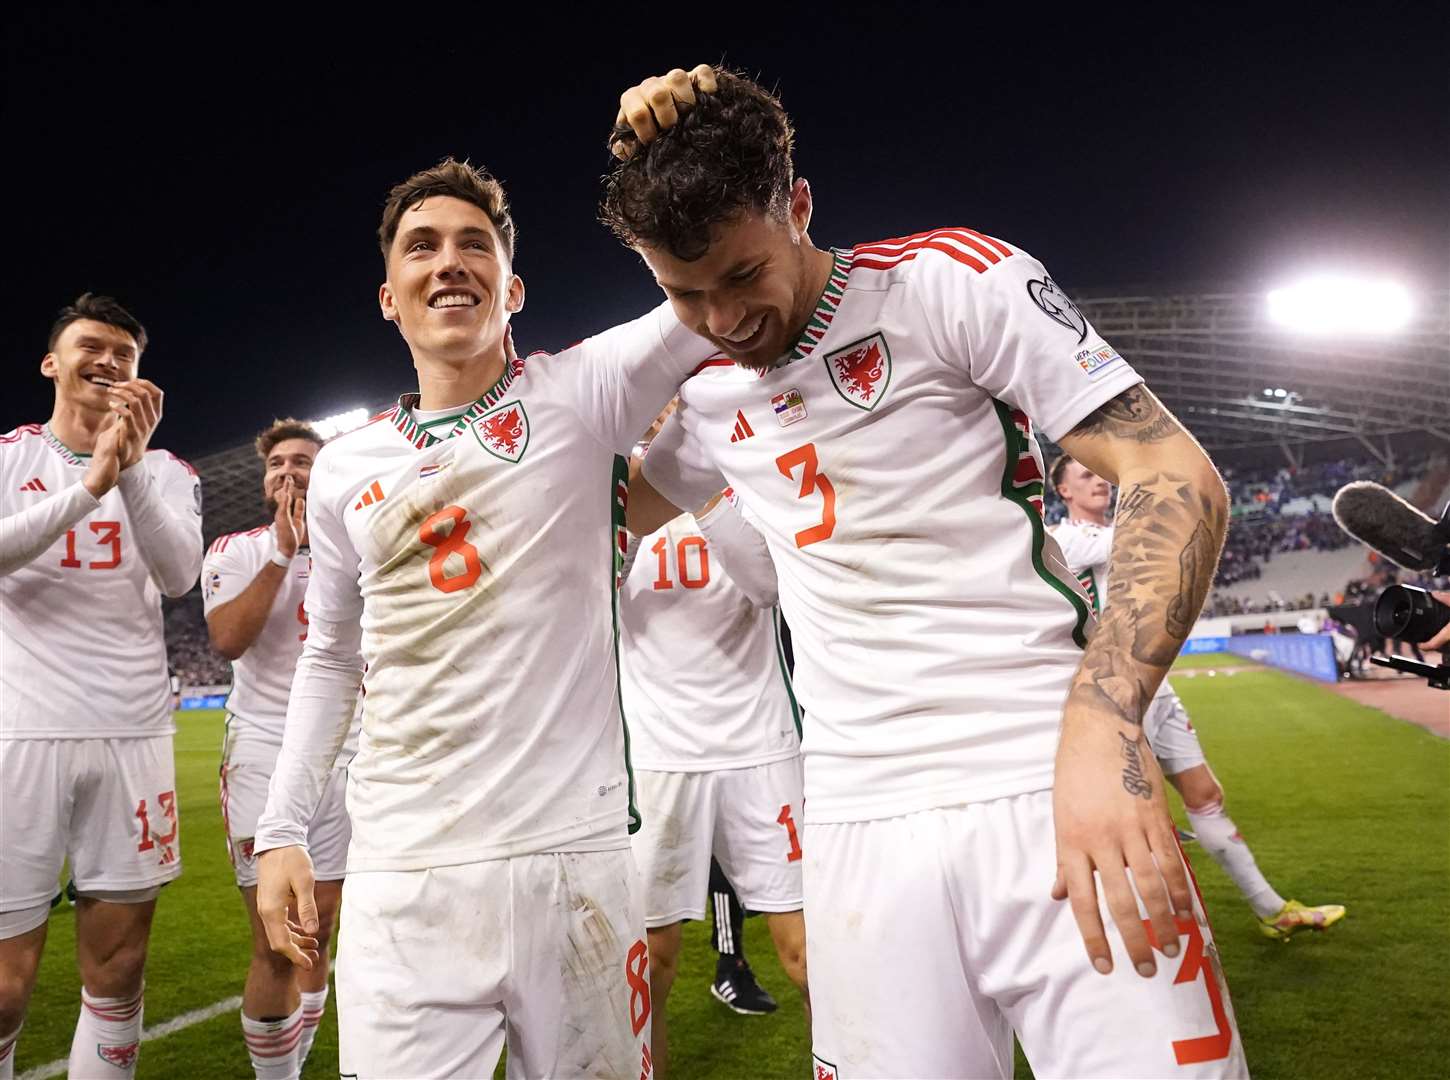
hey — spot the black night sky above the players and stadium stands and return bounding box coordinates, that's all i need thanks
[0,3,1450,457]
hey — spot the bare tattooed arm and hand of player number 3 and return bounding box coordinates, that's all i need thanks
[1053,386,1228,976]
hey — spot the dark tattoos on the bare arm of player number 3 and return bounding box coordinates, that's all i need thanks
[1069,387,1227,724]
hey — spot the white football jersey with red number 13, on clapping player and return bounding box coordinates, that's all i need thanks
[0,423,202,739]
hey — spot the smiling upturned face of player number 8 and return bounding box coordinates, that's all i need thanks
[378,196,523,367]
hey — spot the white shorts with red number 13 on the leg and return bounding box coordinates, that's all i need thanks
[0,735,181,936]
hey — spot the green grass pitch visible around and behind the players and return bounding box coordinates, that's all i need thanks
[16,672,1450,1080]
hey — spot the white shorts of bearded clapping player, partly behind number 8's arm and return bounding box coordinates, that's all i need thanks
[220,723,352,889]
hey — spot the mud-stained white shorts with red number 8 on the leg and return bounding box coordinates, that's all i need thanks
[336,848,653,1080]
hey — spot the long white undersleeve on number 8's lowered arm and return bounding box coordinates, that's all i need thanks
[255,466,363,852]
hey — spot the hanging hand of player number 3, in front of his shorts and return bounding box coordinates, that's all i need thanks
[1053,715,1193,977]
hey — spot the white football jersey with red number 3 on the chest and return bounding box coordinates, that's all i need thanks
[644,229,1140,822]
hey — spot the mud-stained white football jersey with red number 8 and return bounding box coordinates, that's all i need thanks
[306,306,709,871]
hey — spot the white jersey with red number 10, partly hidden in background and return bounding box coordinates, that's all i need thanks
[619,513,800,773]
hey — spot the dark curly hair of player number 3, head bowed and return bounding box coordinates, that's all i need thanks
[599,68,795,262]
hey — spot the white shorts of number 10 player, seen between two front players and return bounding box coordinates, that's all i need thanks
[634,757,803,928]
